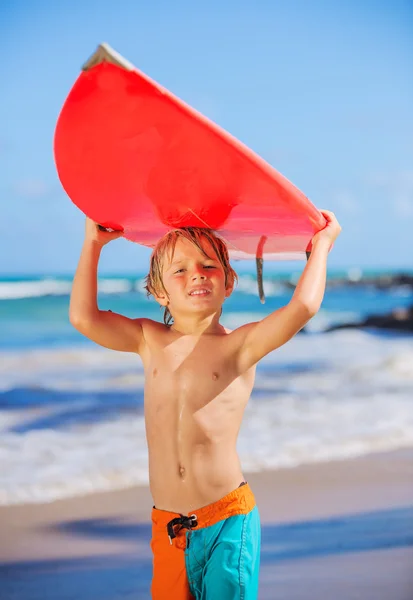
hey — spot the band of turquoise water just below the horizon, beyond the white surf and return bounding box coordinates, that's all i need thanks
[0,271,413,349]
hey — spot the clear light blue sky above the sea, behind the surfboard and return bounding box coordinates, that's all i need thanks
[0,0,413,274]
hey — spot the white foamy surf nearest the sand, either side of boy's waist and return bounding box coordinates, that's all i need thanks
[0,394,413,505]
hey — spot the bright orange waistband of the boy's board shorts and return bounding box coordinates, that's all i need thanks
[152,483,256,529]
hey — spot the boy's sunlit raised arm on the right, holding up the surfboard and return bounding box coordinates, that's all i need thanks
[237,211,341,373]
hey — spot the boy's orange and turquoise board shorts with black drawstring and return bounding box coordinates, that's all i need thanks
[150,481,261,600]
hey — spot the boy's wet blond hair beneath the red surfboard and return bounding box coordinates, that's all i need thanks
[144,227,238,325]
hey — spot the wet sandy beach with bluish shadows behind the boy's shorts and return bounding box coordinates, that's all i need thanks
[0,450,413,600]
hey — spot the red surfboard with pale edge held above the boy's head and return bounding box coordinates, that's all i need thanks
[54,44,326,300]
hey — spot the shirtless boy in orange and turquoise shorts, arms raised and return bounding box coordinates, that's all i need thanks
[70,211,341,600]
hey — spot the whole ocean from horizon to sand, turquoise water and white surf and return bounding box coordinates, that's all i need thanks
[0,269,413,505]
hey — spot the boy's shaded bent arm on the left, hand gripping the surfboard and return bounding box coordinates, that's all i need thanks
[69,218,143,353]
